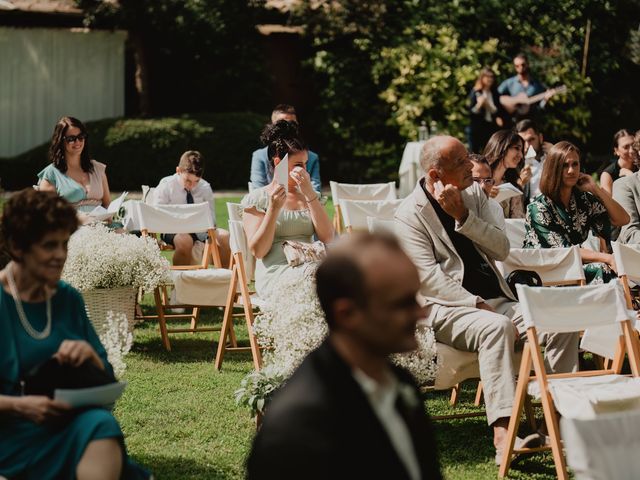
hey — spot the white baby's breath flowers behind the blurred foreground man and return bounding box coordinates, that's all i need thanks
[235,264,438,416]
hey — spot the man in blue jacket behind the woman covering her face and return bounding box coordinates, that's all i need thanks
[249,103,322,193]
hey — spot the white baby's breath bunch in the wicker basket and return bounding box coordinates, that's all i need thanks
[62,224,170,291]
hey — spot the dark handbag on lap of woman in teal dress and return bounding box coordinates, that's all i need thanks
[23,357,116,398]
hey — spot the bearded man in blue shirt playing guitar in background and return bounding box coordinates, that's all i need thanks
[498,53,557,122]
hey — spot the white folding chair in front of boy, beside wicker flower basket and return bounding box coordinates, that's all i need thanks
[133,202,232,350]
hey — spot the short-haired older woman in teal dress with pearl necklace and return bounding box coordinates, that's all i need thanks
[0,189,149,480]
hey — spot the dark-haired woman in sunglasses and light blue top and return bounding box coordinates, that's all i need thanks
[38,117,111,213]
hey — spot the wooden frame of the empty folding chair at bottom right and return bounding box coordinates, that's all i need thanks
[498,284,640,480]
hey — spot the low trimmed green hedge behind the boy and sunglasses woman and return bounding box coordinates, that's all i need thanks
[0,113,268,191]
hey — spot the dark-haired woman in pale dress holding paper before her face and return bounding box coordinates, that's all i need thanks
[242,120,334,296]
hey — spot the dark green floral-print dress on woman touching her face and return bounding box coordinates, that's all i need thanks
[523,188,616,284]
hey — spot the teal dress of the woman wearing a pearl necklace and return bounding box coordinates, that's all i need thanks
[0,282,149,480]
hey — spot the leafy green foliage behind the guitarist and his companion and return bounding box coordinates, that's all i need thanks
[289,0,640,180]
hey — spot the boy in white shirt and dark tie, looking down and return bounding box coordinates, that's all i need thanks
[153,150,231,266]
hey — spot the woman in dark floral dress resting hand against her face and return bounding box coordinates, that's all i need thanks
[524,142,629,283]
